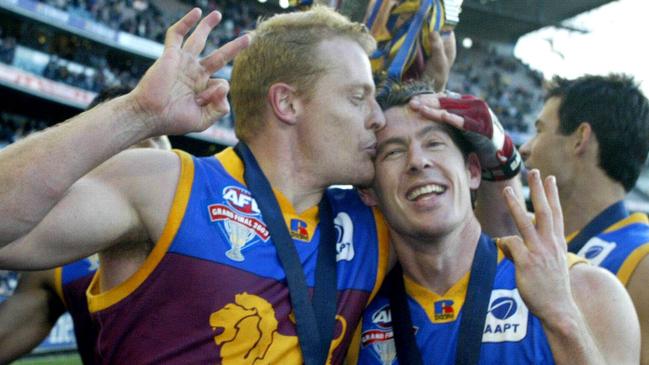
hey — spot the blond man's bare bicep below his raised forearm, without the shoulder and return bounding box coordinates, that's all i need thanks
[0,173,139,270]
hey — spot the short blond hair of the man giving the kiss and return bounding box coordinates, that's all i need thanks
[230,6,376,141]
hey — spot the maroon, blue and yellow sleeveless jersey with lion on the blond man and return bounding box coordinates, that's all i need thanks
[88,148,388,364]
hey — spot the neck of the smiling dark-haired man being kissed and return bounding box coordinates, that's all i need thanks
[390,217,481,295]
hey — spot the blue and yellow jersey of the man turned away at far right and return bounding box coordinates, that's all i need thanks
[568,202,649,286]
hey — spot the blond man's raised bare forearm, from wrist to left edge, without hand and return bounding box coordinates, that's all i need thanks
[0,96,149,247]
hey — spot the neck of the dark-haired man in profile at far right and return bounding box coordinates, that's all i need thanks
[559,168,626,235]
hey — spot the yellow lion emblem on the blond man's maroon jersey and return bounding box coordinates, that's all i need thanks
[210,292,347,365]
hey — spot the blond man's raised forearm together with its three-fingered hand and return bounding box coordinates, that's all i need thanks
[0,9,249,247]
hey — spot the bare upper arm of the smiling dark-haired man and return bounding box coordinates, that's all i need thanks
[570,265,640,364]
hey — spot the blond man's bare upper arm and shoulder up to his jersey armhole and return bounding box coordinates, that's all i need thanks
[0,148,181,270]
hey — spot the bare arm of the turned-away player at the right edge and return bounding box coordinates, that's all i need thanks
[627,255,649,365]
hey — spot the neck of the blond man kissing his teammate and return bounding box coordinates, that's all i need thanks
[248,137,328,214]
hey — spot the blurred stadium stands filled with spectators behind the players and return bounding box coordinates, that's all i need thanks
[0,0,649,360]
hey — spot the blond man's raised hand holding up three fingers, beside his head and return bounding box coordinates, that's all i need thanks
[132,8,250,135]
